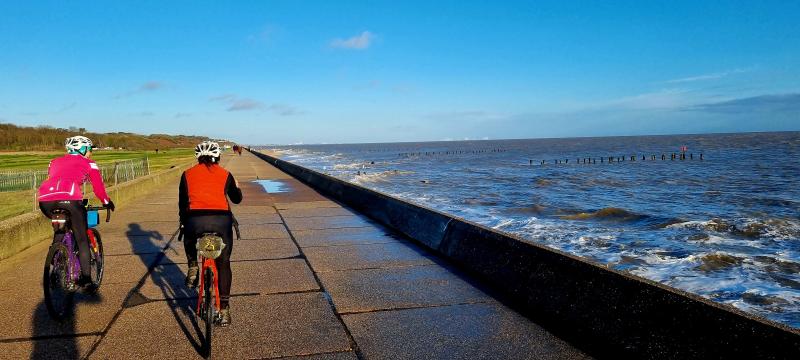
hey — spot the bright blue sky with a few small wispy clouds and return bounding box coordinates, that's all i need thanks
[0,0,800,144]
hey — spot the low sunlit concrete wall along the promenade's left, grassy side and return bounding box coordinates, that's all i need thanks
[0,163,193,261]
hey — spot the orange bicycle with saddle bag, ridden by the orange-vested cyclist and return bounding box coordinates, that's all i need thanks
[196,232,225,358]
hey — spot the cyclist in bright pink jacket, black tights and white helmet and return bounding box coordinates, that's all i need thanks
[39,136,114,286]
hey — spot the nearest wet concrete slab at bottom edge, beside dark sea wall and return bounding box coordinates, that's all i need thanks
[343,304,587,359]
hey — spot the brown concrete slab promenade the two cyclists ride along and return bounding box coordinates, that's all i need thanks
[0,153,587,359]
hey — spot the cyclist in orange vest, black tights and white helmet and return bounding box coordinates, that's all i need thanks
[178,141,242,326]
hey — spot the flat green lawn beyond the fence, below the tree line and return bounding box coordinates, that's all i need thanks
[0,149,194,172]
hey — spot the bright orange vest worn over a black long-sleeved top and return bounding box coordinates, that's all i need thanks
[185,164,230,210]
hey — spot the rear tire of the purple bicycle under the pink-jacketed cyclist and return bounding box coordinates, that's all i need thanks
[42,243,75,320]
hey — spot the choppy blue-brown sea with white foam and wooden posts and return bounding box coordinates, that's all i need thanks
[268,132,800,328]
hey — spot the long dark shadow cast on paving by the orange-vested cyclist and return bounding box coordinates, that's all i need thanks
[126,223,204,356]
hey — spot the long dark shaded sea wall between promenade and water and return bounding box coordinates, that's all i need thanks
[254,152,800,359]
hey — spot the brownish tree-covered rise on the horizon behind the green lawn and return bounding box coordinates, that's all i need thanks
[0,123,206,151]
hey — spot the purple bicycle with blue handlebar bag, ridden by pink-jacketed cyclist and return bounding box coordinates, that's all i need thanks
[42,199,111,320]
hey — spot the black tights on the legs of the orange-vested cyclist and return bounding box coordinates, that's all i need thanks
[183,215,233,307]
